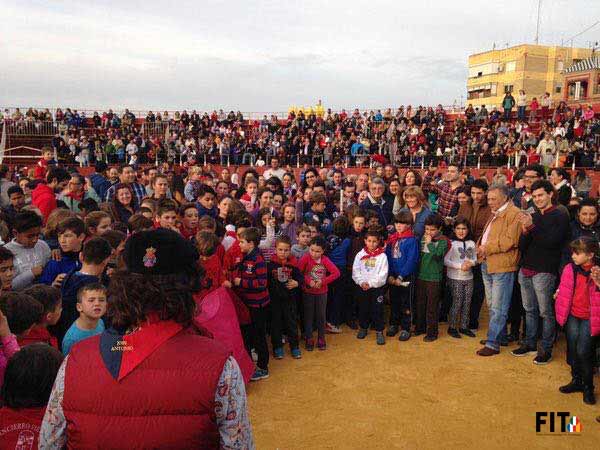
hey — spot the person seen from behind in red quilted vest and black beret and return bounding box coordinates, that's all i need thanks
[39,229,255,449]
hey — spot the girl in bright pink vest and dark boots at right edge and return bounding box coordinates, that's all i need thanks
[555,237,600,405]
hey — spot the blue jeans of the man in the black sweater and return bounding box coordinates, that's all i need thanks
[519,270,556,354]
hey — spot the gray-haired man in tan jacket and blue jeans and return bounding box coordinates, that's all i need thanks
[477,184,521,356]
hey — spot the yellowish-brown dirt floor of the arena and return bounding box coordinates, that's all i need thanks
[248,311,600,450]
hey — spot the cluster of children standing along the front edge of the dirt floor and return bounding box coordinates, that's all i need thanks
[190,179,486,380]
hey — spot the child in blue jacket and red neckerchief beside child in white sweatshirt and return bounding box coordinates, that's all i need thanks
[386,211,419,341]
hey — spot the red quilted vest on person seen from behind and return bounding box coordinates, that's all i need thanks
[63,329,229,449]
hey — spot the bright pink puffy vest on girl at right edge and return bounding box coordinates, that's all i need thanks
[555,263,600,336]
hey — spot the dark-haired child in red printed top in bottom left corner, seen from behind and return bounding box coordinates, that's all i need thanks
[0,344,63,449]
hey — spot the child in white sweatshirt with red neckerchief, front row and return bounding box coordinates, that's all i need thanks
[352,227,388,345]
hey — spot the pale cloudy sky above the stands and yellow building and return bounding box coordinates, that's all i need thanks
[0,0,600,111]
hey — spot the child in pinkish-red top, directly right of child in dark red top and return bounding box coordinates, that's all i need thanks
[298,237,340,352]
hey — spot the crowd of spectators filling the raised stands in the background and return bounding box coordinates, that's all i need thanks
[0,97,600,167]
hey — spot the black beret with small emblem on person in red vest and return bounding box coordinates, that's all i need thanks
[123,228,199,275]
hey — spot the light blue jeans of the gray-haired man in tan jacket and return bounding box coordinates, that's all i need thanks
[481,263,515,350]
